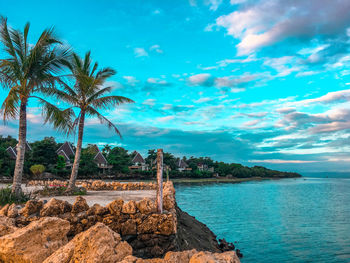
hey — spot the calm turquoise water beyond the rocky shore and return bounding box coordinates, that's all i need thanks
[176,178,350,263]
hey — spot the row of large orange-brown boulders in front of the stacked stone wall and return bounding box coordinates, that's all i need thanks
[0,216,239,263]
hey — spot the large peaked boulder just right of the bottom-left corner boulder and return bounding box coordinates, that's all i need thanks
[43,223,132,263]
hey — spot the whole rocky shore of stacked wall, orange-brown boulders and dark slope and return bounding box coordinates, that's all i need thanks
[0,182,239,263]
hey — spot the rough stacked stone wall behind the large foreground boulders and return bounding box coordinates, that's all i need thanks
[0,181,177,257]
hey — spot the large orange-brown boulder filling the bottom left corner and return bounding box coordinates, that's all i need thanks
[0,217,70,263]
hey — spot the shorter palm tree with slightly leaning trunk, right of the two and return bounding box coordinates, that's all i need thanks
[55,52,133,192]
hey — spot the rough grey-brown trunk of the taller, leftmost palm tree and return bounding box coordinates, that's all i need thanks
[12,99,27,196]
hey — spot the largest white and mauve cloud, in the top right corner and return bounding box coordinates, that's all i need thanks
[216,0,350,55]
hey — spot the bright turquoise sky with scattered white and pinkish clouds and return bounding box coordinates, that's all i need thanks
[0,0,350,173]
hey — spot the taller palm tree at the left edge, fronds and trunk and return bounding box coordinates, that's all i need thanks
[0,17,70,195]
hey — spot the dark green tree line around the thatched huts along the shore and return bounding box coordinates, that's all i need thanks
[0,136,300,182]
